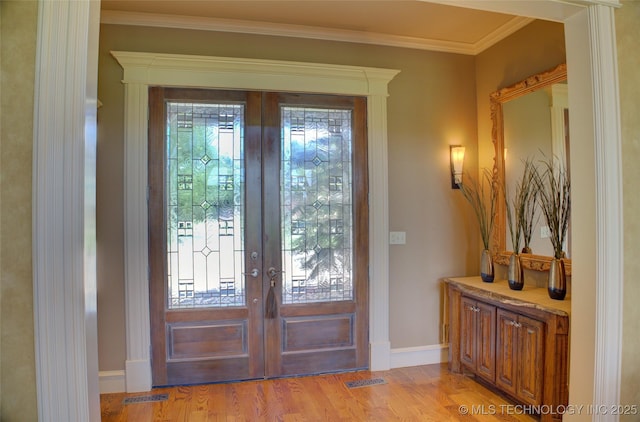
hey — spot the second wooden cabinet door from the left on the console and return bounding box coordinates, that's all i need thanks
[476,302,496,382]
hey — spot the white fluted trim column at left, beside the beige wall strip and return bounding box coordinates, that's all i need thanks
[33,0,100,422]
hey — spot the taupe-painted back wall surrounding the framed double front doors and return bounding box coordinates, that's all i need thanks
[97,25,479,370]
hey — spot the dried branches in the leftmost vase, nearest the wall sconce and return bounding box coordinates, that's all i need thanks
[459,169,498,250]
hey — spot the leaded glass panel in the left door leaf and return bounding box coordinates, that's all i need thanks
[166,101,245,309]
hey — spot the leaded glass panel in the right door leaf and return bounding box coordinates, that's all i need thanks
[280,106,353,304]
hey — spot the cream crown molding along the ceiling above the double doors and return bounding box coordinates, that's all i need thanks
[100,10,533,55]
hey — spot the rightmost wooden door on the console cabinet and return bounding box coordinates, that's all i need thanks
[516,315,544,405]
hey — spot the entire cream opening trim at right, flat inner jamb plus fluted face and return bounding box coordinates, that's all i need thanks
[564,4,624,421]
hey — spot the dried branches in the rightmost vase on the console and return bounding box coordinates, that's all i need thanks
[535,159,571,259]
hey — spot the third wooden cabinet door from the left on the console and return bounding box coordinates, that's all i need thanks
[496,309,518,396]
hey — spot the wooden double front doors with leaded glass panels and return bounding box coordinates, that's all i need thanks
[149,87,369,386]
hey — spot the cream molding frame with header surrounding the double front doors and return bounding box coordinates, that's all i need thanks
[111,51,399,392]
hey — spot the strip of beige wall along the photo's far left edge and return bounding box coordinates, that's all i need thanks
[0,0,38,422]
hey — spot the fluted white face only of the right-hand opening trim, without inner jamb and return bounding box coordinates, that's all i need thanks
[589,5,624,421]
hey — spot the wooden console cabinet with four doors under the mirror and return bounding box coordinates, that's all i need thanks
[445,277,571,422]
